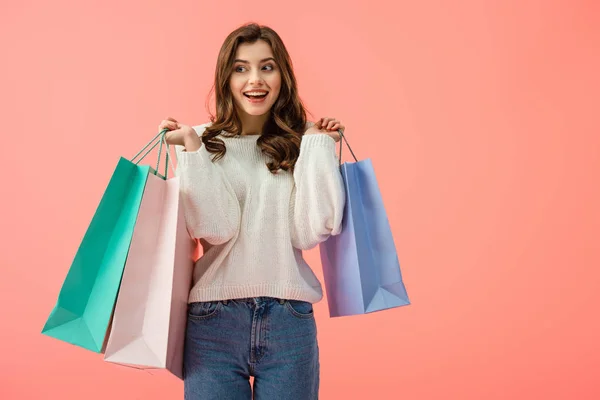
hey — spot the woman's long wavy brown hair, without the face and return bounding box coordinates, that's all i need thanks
[202,23,307,173]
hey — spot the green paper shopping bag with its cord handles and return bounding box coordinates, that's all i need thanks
[42,131,169,353]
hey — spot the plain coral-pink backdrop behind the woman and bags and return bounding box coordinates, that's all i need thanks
[0,0,600,400]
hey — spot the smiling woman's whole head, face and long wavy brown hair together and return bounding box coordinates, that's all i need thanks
[197,24,316,173]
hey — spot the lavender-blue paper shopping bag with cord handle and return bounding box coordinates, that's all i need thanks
[319,132,410,317]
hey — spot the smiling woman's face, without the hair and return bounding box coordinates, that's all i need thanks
[229,40,281,116]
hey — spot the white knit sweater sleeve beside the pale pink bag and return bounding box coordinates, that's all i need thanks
[175,126,240,245]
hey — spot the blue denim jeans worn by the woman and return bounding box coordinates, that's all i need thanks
[183,297,319,400]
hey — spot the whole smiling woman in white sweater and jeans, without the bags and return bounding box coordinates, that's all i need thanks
[159,24,345,400]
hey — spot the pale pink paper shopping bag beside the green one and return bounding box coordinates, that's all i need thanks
[104,144,195,379]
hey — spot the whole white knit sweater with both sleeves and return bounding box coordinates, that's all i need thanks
[176,123,345,303]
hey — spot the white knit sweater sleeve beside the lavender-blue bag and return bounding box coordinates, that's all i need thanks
[290,134,346,250]
